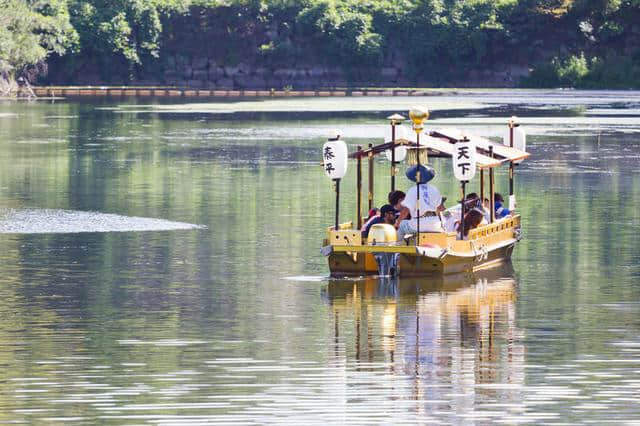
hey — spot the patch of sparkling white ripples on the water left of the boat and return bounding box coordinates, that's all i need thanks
[0,209,206,234]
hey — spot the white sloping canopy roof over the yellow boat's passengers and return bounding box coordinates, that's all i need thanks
[349,128,530,169]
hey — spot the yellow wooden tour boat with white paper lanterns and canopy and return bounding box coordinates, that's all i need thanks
[321,109,529,277]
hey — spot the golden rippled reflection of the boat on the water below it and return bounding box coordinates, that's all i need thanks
[324,264,524,386]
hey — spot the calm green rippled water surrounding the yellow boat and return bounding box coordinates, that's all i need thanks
[0,91,640,425]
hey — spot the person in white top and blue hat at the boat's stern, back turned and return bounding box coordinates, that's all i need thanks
[398,164,444,240]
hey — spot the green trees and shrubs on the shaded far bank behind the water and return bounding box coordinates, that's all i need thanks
[0,0,640,88]
